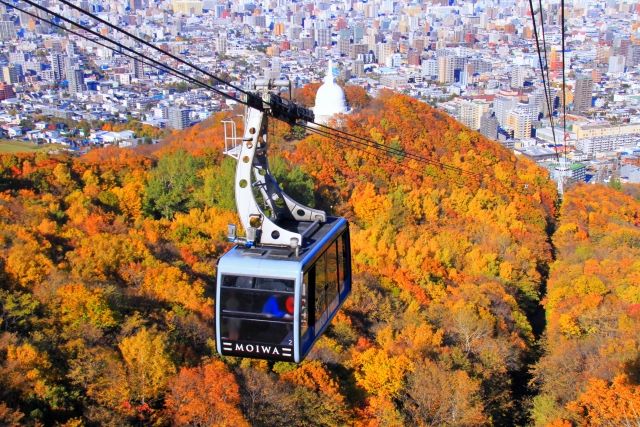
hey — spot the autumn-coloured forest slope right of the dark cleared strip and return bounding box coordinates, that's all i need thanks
[533,185,640,426]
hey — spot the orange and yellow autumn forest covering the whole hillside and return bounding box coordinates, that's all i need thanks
[0,86,640,427]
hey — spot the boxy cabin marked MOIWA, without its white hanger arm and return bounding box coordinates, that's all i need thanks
[216,218,351,362]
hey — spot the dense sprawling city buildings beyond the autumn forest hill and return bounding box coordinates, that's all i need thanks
[0,0,640,187]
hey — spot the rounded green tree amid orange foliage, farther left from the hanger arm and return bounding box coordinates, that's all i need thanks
[144,150,202,218]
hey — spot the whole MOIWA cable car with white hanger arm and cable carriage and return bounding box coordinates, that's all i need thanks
[216,81,351,363]
